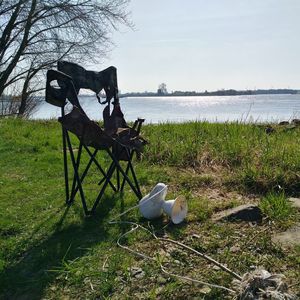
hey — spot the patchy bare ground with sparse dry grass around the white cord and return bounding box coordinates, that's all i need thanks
[112,169,300,299]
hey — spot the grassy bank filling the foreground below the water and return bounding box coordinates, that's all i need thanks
[0,119,300,299]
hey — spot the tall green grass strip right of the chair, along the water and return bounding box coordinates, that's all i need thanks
[145,122,300,194]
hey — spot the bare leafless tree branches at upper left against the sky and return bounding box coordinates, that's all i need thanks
[0,0,131,115]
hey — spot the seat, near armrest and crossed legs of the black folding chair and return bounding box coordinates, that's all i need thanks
[46,70,145,214]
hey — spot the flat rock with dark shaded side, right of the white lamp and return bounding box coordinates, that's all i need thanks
[212,204,263,222]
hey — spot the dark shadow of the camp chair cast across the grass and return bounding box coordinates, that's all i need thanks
[0,195,123,299]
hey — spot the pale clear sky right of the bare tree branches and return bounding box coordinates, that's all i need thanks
[101,0,300,92]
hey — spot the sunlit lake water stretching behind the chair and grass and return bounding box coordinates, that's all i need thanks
[32,94,300,123]
